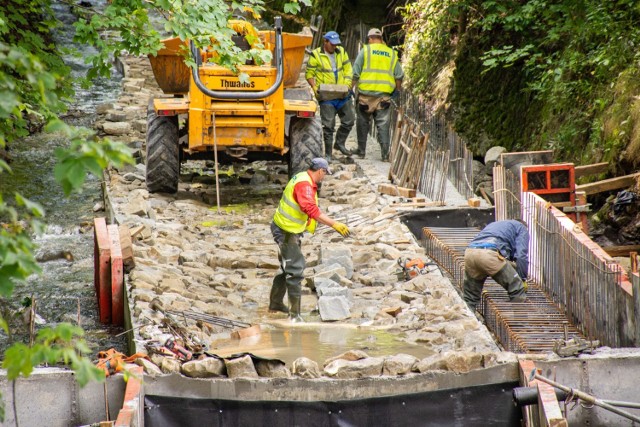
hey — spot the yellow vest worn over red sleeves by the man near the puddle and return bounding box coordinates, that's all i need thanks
[273,171,318,234]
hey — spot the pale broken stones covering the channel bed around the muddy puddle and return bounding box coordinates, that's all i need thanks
[97,57,510,378]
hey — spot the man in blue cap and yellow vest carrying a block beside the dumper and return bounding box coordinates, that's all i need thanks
[304,31,356,161]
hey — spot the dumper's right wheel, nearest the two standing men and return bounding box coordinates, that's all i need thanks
[289,117,324,177]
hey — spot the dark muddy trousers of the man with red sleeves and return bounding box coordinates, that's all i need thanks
[270,222,306,310]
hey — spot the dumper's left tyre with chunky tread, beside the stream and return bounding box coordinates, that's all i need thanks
[146,102,180,193]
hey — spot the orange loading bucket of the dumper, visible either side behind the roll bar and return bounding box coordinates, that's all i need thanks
[149,31,313,94]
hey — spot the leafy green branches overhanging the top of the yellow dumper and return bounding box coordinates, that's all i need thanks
[75,0,310,78]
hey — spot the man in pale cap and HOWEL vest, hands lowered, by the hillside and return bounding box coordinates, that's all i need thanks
[353,28,404,161]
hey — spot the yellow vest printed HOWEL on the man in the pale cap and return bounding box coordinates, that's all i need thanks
[358,43,398,94]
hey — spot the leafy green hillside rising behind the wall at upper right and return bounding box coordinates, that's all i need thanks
[404,0,640,174]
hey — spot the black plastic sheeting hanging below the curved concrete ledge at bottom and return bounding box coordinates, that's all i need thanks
[144,382,521,427]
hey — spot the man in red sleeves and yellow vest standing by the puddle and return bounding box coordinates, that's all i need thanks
[269,157,350,322]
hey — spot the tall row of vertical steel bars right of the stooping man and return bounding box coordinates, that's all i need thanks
[494,166,640,347]
